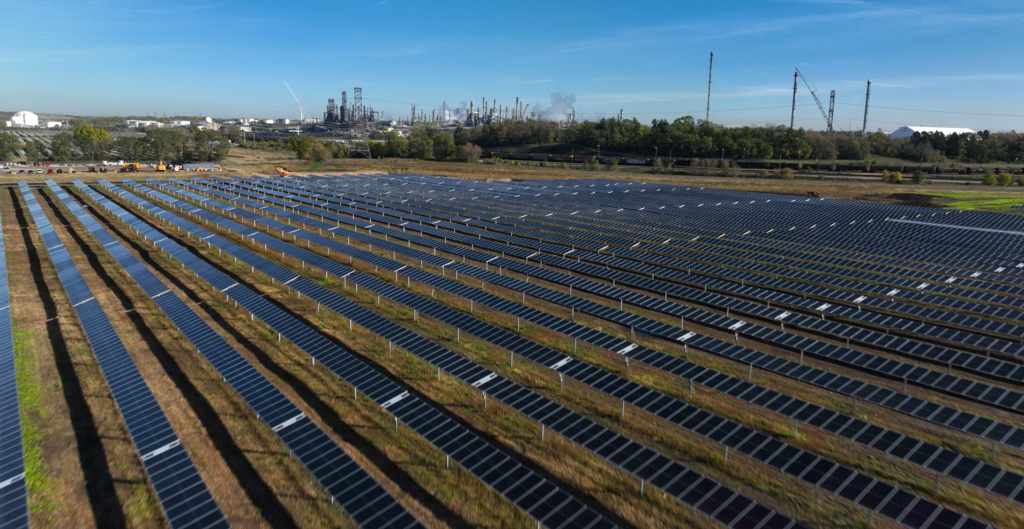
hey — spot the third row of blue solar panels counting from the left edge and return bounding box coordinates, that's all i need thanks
[58,180,423,528]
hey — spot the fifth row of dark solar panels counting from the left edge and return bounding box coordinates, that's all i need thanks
[123,178,815,527]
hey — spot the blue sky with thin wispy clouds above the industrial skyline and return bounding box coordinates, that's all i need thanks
[0,0,1024,130]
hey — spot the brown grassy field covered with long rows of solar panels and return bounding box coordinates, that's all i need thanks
[6,165,1024,529]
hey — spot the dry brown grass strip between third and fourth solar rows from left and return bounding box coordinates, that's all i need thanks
[73,185,569,527]
